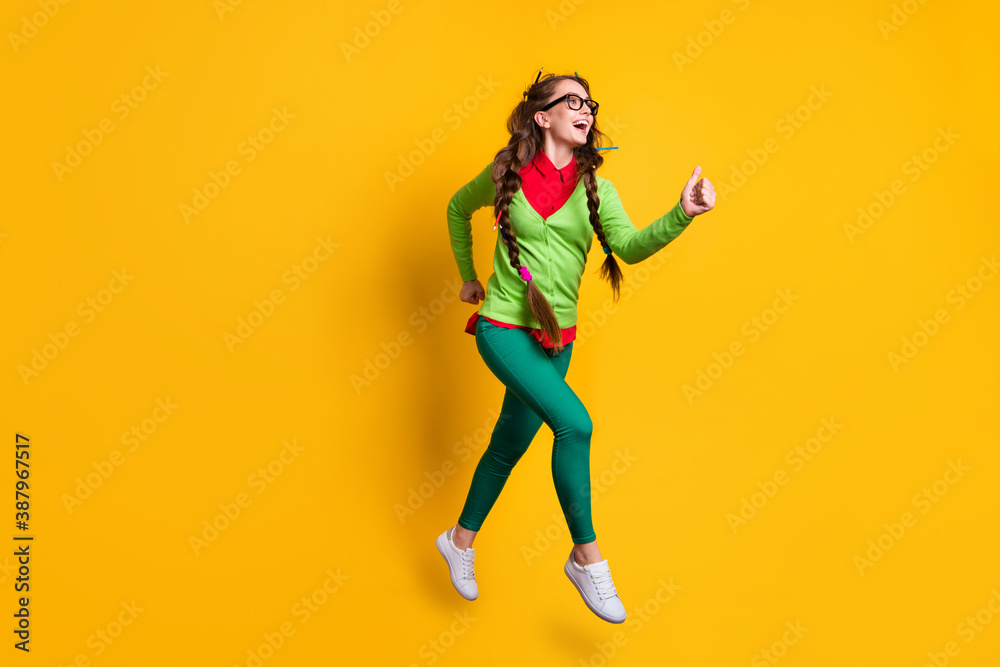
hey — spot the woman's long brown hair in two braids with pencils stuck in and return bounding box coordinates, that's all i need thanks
[493,73,622,353]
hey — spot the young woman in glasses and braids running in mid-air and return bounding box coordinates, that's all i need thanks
[437,72,715,623]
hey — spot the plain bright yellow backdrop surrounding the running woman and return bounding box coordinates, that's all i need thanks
[0,0,1000,667]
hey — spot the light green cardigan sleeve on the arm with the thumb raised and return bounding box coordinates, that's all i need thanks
[598,181,694,264]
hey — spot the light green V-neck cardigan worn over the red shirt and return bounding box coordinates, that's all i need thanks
[447,162,692,329]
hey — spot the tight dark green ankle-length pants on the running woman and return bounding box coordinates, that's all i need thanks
[458,317,597,544]
